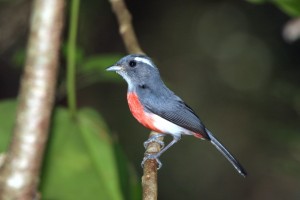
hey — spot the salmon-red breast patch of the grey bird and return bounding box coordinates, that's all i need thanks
[127,92,162,133]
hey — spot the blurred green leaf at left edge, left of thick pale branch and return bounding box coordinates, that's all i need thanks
[0,99,17,153]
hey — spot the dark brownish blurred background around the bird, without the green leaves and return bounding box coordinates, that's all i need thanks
[0,0,300,200]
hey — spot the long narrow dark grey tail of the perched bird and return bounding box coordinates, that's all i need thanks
[206,129,247,177]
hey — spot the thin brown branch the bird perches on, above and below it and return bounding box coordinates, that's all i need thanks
[109,0,160,200]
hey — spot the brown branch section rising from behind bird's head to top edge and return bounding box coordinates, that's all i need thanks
[109,0,144,54]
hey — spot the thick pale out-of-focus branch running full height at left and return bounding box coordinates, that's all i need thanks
[0,0,64,200]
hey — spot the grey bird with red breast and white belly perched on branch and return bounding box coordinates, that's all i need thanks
[106,54,247,177]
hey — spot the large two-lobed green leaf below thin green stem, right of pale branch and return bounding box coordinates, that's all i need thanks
[41,108,123,200]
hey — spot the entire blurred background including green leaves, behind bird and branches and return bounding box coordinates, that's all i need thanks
[0,0,300,200]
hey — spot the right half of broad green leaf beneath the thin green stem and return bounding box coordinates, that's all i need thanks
[78,109,122,199]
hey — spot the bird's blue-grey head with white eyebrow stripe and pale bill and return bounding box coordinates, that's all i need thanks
[106,54,162,90]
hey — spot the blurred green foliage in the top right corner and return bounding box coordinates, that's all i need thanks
[248,0,300,17]
